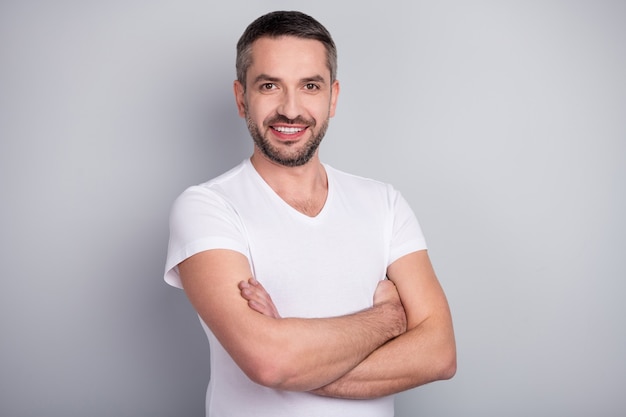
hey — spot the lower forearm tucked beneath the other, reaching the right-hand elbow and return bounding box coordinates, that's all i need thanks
[312,319,456,399]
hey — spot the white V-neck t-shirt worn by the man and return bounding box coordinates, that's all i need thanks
[165,159,426,417]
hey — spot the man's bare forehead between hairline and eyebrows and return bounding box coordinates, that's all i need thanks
[247,36,330,80]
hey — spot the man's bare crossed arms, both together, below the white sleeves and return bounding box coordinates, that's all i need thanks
[179,250,456,398]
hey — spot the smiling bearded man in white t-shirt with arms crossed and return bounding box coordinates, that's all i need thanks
[165,12,456,417]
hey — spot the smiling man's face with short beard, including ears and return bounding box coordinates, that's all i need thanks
[235,36,339,167]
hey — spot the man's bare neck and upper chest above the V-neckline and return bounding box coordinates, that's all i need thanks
[250,153,328,217]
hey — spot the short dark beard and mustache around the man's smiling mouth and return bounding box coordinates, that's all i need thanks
[246,110,328,167]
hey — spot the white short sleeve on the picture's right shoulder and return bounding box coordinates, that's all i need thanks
[389,189,427,265]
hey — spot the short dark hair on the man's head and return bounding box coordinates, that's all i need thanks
[235,11,337,88]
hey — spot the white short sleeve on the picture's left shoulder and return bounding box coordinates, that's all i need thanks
[164,185,249,288]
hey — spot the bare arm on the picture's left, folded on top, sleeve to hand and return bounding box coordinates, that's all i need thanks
[179,250,407,391]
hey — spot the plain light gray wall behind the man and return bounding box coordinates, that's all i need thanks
[0,0,626,417]
